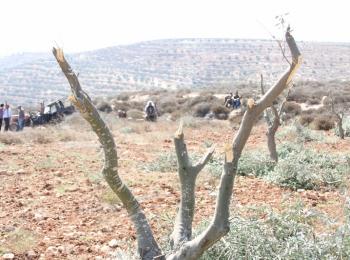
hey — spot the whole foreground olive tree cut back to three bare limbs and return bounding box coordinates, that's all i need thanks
[53,27,301,260]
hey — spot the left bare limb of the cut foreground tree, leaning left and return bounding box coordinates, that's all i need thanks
[53,48,164,260]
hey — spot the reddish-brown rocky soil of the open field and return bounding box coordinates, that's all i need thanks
[0,116,350,259]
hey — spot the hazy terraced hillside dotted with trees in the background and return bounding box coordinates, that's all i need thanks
[0,39,350,104]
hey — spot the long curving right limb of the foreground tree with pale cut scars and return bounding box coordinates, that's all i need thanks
[167,28,301,260]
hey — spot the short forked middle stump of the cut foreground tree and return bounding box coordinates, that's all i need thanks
[170,123,215,249]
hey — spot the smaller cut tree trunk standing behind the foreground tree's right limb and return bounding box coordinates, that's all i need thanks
[260,74,290,163]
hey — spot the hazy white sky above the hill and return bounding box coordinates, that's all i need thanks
[0,0,350,56]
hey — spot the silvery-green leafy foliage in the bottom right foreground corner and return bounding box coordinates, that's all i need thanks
[201,205,350,260]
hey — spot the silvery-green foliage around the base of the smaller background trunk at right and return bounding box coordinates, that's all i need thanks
[234,143,350,190]
